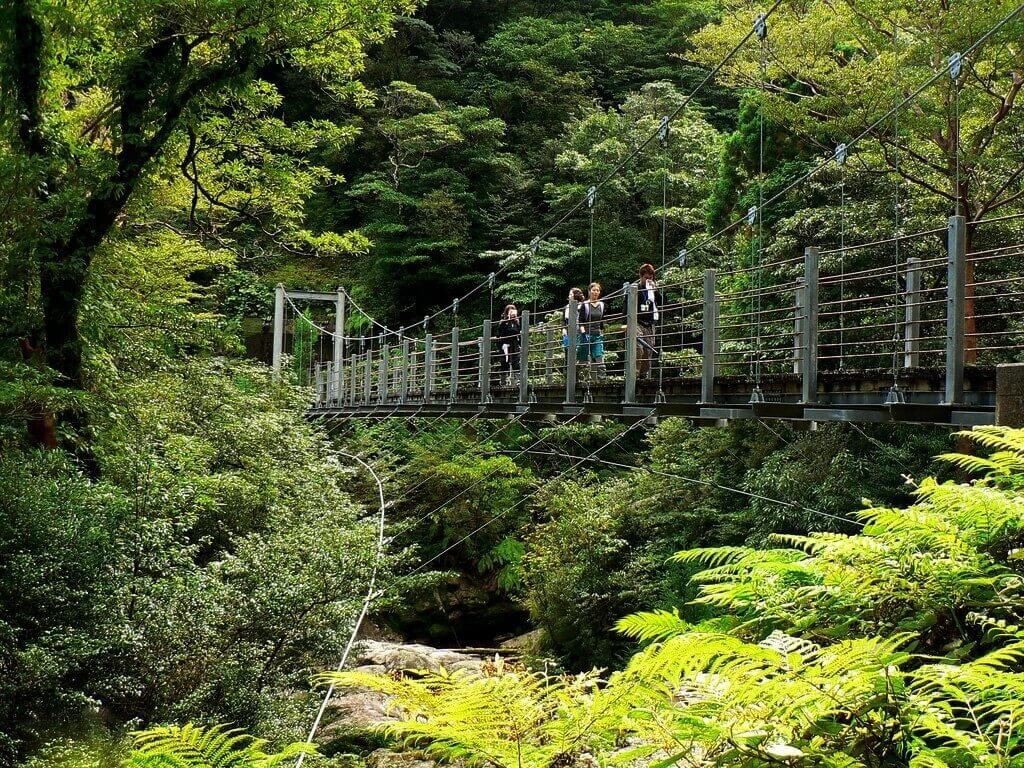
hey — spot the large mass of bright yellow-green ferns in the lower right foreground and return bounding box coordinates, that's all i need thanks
[331,428,1024,768]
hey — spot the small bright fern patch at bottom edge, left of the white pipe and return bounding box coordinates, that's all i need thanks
[128,724,316,768]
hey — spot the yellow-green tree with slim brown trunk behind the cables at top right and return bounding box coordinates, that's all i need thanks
[695,0,1024,359]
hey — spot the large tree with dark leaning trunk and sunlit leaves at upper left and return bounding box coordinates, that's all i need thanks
[0,0,412,386]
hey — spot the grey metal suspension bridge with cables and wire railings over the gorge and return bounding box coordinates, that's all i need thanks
[272,2,1024,426]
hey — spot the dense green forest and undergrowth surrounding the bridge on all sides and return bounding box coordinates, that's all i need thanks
[0,0,1024,768]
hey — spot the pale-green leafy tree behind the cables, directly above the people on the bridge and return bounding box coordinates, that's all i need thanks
[497,83,720,300]
